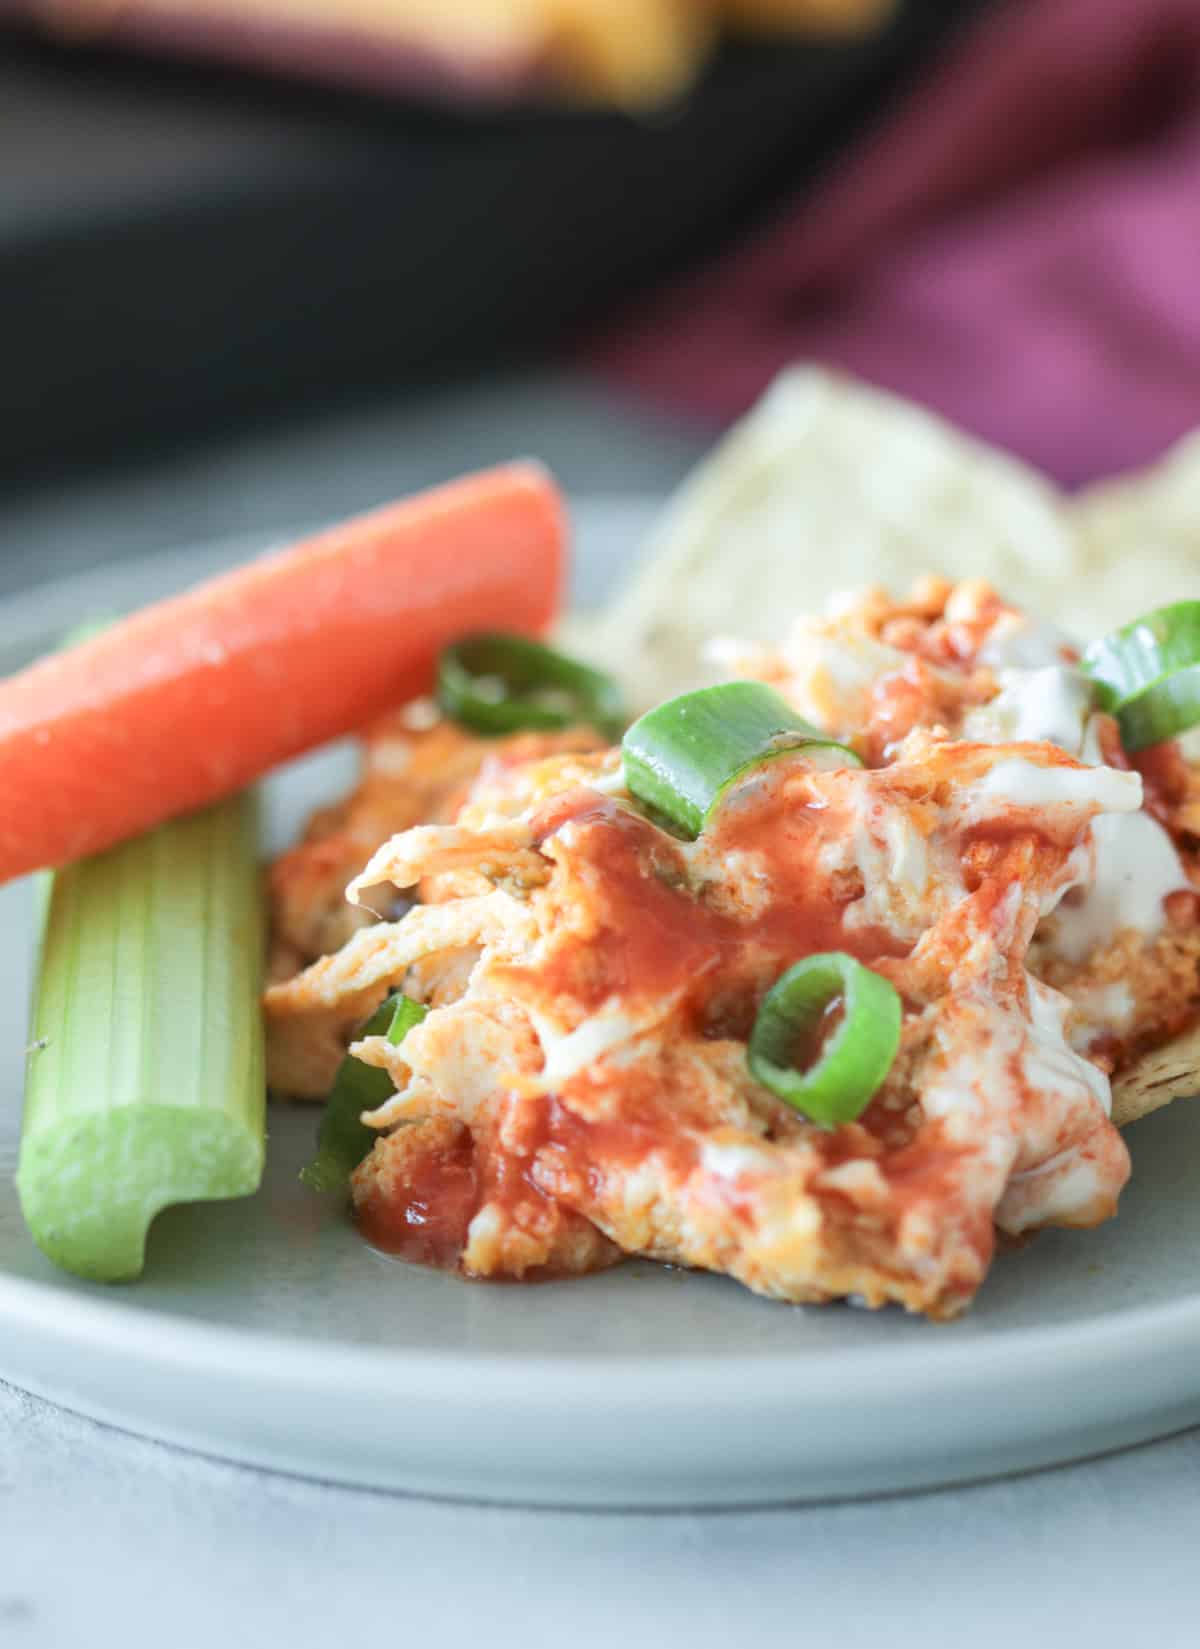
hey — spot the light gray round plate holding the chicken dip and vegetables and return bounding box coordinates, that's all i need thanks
[0,503,1200,1506]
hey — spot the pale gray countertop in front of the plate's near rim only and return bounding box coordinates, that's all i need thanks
[0,1388,1200,1649]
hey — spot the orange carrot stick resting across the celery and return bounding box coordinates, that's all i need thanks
[0,463,565,881]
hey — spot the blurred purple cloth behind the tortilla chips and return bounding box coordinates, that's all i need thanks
[588,0,1200,484]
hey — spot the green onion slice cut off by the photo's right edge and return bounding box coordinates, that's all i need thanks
[1080,602,1200,750]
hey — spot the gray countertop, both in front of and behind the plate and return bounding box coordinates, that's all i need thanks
[0,376,1200,1649]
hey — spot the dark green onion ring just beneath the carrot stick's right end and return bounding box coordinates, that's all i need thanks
[437,632,626,739]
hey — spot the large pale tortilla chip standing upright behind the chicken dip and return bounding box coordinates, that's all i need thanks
[588,369,1073,702]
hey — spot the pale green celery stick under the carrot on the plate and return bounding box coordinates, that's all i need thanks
[16,795,265,1281]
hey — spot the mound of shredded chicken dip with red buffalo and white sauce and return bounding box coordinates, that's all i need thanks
[265,582,1200,1316]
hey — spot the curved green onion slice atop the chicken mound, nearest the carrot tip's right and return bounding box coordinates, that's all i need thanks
[621,681,862,839]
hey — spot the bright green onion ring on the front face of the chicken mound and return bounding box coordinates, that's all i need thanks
[747,950,902,1128]
